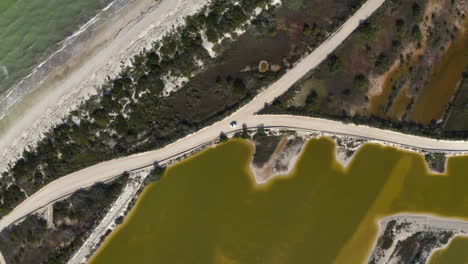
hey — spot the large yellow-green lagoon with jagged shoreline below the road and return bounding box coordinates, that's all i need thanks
[91,138,468,264]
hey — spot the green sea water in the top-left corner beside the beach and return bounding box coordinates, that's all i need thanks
[0,0,111,93]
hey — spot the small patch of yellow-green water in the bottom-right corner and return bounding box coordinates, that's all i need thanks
[428,237,468,264]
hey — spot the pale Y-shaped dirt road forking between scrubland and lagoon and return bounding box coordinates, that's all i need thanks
[0,0,458,230]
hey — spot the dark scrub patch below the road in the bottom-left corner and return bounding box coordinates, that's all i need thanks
[0,177,128,264]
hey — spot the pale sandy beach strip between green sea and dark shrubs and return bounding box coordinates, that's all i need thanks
[0,0,209,171]
